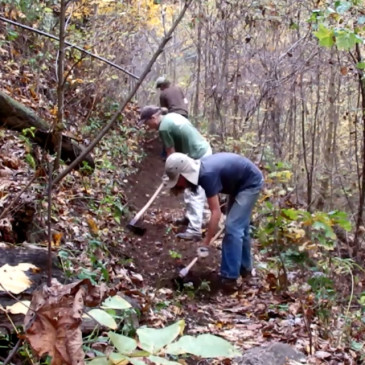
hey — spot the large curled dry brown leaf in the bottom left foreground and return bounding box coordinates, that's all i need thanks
[24,279,106,365]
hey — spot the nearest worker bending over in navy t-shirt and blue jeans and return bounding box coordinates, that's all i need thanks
[165,152,264,286]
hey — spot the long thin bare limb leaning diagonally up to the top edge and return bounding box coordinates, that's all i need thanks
[53,0,192,185]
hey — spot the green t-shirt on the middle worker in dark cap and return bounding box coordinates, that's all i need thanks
[158,113,209,160]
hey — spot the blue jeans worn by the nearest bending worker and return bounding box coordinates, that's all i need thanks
[221,184,262,279]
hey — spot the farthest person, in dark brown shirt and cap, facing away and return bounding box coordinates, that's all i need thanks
[156,76,188,118]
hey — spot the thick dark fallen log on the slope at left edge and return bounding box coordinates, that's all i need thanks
[0,91,95,169]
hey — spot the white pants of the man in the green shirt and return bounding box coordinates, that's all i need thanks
[184,147,212,234]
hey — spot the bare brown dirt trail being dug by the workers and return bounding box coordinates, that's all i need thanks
[126,140,220,287]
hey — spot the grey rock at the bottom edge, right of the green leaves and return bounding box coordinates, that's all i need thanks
[235,342,305,365]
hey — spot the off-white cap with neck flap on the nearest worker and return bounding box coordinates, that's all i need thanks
[165,152,200,189]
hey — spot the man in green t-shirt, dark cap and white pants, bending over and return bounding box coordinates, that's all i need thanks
[139,105,212,240]
